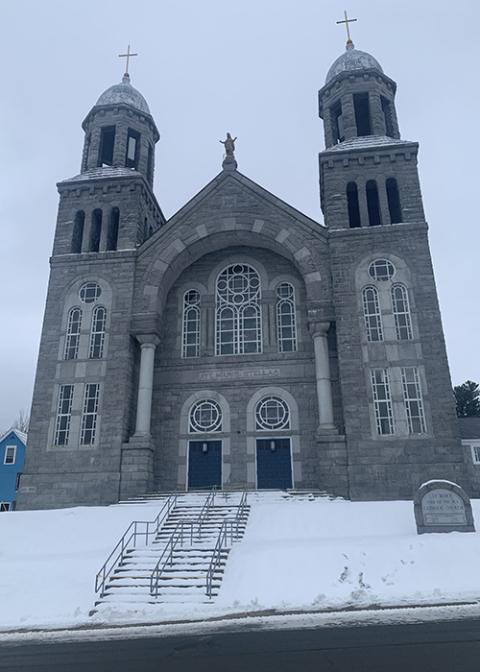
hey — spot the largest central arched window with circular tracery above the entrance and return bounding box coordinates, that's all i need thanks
[215,264,262,355]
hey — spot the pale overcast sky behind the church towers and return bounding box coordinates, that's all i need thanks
[0,0,480,429]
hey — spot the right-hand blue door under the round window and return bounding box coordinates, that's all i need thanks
[257,439,292,490]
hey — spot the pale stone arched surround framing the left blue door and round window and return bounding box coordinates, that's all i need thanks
[177,390,231,490]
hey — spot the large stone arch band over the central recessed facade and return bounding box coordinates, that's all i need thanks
[135,218,331,315]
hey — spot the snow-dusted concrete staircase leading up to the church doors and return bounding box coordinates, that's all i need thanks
[95,492,249,608]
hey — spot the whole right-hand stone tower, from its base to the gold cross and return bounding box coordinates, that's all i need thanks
[318,25,468,499]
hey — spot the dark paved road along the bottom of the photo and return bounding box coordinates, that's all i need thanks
[0,620,480,672]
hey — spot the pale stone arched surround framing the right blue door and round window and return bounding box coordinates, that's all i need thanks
[247,385,302,488]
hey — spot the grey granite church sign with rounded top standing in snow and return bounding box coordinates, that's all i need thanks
[414,480,475,534]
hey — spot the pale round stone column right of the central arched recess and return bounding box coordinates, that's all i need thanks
[309,322,335,432]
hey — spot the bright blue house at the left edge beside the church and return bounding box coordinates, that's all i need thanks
[0,429,27,512]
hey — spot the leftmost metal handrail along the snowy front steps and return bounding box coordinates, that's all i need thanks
[95,495,177,597]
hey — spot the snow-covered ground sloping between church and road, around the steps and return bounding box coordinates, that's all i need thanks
[0,493,480,630]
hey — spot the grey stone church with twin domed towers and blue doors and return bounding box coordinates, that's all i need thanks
[18,40,472,509]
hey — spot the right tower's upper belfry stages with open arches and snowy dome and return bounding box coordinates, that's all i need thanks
[318,30,424,229]
